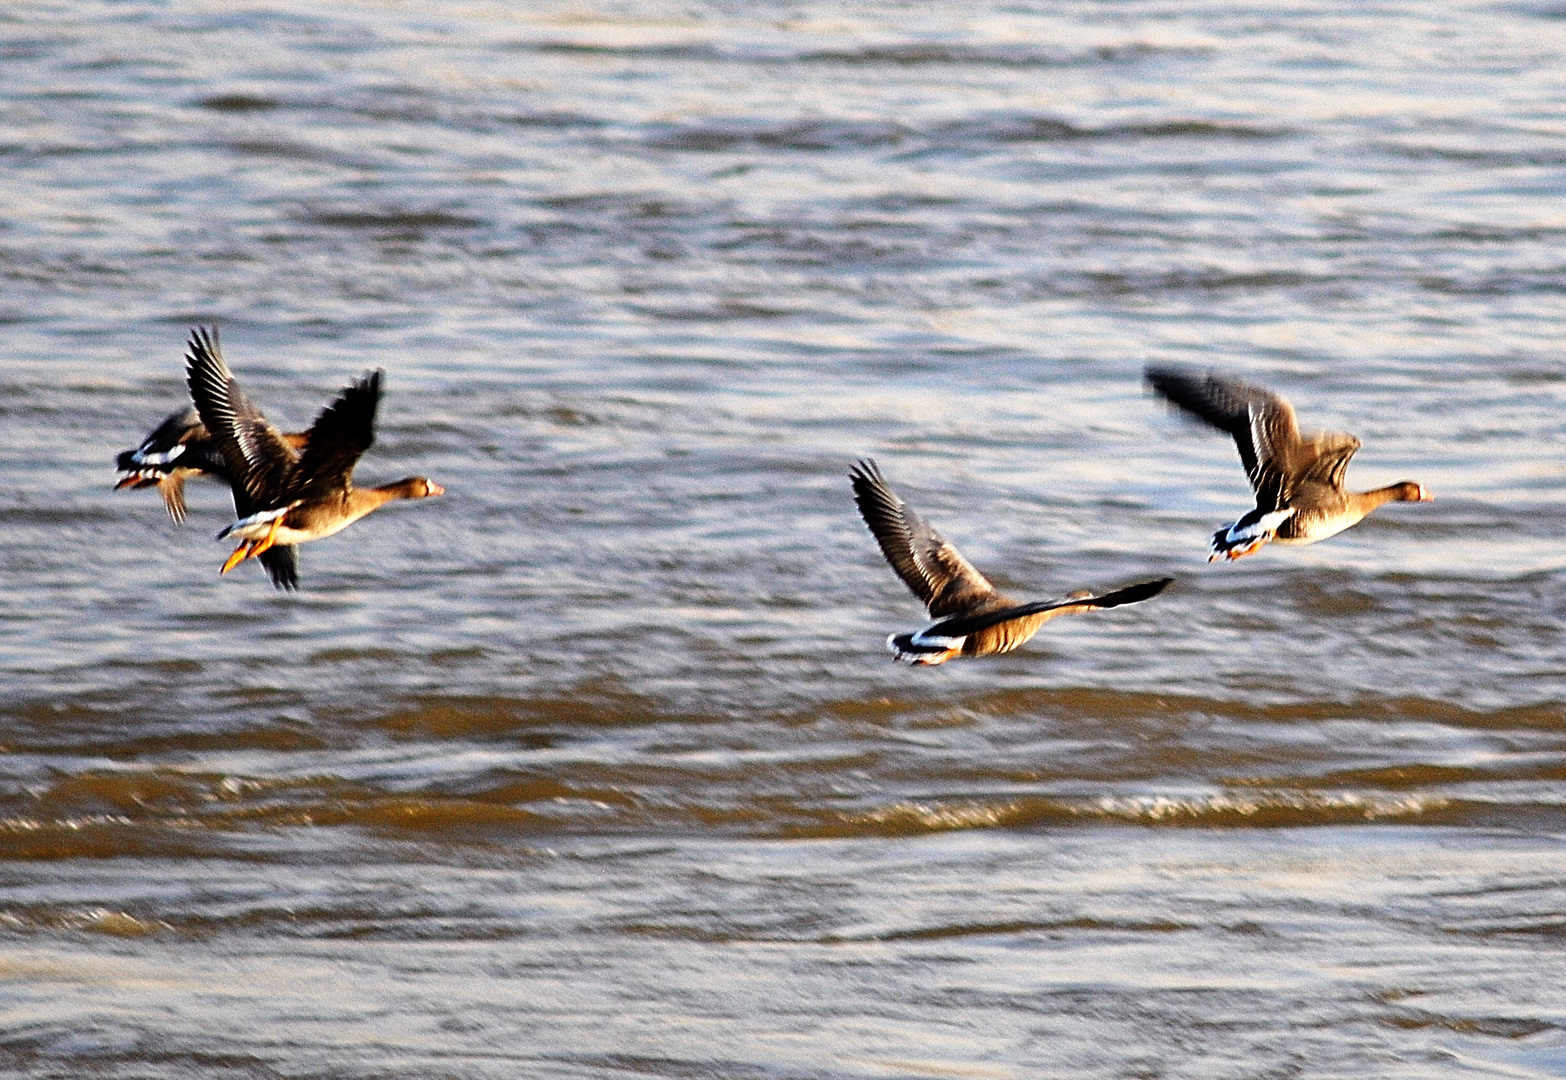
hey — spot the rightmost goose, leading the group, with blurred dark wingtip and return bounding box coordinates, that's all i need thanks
[1145,365,1434,562]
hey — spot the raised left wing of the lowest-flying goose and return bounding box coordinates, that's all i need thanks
[849,459,1009,618]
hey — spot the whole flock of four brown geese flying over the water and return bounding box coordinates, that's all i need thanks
[116,327,1431,665]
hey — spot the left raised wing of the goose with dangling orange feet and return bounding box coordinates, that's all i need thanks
[185,327,298,517]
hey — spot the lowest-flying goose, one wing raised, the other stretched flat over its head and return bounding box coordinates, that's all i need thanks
[849,459,1173,665]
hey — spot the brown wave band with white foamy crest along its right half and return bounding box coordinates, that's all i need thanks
[12,765,1566,859]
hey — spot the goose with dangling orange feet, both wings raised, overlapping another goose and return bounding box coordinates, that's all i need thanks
[185,327,445,589]
